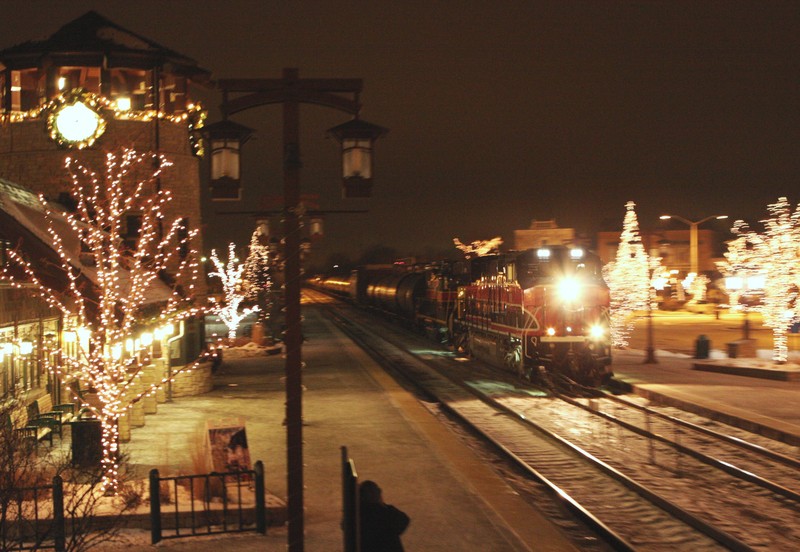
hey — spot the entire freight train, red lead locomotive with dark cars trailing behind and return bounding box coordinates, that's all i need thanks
[309,246,613,386]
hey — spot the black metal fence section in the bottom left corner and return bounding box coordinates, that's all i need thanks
[0,476,66,552]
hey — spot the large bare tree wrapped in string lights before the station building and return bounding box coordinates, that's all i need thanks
[3,149,205,493]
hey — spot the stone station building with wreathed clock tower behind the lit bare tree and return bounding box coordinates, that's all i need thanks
[0,11,210,418]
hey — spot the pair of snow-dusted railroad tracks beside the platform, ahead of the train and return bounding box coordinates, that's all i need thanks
[304,292,800,550]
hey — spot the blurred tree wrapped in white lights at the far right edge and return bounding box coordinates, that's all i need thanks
[725,197,800,364]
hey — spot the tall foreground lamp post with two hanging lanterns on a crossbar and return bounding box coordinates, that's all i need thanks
[206,68,387,552]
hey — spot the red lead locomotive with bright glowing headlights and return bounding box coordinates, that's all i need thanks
[454,247,611,384]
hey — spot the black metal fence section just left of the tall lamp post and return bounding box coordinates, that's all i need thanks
[150,460,267,544]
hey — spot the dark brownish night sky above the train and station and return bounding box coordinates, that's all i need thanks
[0,0,800,270]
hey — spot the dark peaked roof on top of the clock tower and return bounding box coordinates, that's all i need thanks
[0,11,211,83]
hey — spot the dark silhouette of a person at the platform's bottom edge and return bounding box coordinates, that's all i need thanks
[358,481,411,552]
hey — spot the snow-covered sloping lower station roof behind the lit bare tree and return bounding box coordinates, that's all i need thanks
[0,178,172,304]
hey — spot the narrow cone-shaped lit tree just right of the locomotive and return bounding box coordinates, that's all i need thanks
[603,201,651,348]
